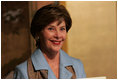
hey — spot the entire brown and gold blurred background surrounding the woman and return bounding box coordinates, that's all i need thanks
[1,1,117,79]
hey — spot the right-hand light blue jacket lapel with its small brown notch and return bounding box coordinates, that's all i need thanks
[60,50,76,79]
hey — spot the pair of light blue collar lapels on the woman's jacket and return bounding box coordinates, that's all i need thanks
[31,49,73,79]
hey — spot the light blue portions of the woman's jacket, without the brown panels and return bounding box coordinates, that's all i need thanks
[14,49,86,79]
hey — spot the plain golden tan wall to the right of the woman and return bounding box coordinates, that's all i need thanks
[66,1,117,78]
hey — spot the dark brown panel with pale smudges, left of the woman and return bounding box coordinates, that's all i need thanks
[1,1,31,78]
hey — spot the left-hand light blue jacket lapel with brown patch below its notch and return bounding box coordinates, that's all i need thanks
[31,49,56,79]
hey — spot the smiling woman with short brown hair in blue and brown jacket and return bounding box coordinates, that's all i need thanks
[14,4,86,79]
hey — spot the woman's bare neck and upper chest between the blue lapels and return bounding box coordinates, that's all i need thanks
[39,47,60,78]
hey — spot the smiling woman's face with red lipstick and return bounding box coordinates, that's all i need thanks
[39,21,66,53]
